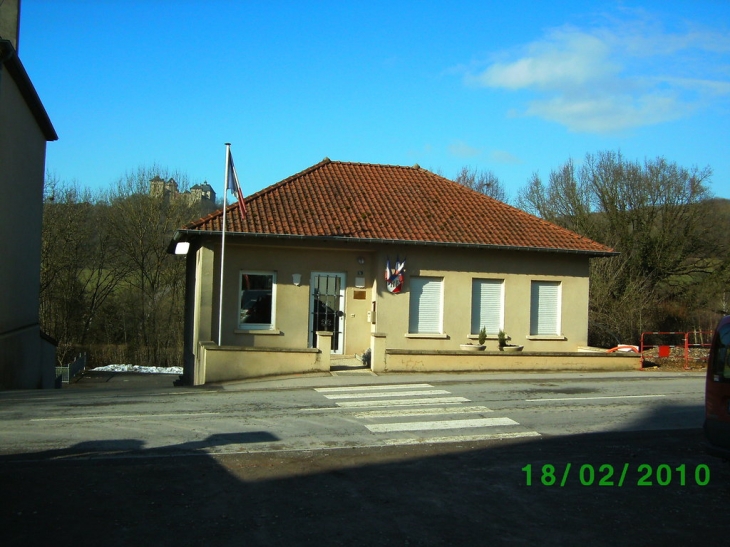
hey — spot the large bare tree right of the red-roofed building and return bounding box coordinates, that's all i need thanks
[518,152,728,341]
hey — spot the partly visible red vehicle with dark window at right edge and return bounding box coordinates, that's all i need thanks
[704,315,730,459]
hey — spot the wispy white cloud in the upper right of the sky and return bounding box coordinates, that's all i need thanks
[465,17,730,133]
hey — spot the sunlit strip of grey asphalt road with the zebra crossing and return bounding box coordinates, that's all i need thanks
[0,372,703,453]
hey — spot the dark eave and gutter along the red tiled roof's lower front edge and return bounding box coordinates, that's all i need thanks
[167,230,621,257]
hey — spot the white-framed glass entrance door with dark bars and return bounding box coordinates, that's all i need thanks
[309,272,345,354]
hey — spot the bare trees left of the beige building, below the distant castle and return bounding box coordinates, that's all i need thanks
[40,166,209,366]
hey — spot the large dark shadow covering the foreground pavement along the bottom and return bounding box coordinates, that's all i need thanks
[0,405,730,546]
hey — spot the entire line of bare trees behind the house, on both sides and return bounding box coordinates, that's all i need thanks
[40,152,730,366]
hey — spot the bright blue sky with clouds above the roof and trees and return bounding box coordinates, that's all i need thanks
[19,0,730,198]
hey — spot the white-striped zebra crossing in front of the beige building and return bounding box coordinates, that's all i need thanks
[314,384,540,444]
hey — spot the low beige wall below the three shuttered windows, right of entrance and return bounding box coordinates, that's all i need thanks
[382,349,641,372]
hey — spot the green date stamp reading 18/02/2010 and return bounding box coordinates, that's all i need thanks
[522,463,710,487]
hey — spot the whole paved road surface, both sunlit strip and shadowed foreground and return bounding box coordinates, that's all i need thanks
[0,373,730,545]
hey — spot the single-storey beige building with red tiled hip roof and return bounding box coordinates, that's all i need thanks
[170,159,632,384]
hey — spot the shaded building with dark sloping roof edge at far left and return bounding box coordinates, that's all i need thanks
[0,22,58,389]
